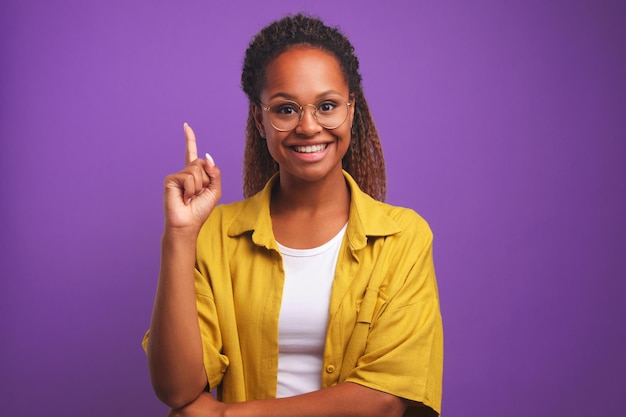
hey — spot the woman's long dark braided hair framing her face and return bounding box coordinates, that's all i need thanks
[241,14,386,201]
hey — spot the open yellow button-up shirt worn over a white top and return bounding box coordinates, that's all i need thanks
[144,172,443,412]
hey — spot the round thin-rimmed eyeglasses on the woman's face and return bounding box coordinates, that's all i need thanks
[259,100,352,132]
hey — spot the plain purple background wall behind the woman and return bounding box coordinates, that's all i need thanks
[0,0,626,417]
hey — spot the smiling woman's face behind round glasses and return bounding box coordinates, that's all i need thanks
[255,46,354,186]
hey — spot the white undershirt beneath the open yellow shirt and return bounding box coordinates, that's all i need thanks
[276,225,347,398]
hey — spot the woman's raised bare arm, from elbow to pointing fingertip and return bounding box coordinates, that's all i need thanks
[147,124,221,408]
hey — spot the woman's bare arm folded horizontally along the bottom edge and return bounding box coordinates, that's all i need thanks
[168,382,407,417]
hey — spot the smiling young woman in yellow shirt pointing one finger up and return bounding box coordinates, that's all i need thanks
[144,15,443,417]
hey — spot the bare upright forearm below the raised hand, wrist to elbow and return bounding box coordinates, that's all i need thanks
[148,229,207,408]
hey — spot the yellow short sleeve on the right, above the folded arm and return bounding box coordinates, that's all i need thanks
[346,218,443,412]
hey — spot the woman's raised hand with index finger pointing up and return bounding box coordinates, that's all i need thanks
[164,123,222,234]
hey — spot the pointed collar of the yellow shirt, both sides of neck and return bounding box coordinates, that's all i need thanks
[228,171,400,250]
